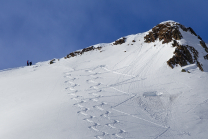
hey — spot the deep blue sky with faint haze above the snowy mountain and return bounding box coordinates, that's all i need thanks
[0,0,208,70]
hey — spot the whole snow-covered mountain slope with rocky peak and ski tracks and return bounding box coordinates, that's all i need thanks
[0,21,208,139]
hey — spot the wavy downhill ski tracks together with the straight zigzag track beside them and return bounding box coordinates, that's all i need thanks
[65,66,169,139]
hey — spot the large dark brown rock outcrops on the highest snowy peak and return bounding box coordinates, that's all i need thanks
[144,21,208,71]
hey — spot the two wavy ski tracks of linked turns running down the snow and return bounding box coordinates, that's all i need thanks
[65,70,130,138]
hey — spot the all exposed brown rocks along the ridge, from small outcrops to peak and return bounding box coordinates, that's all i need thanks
[49,21,208,71]
